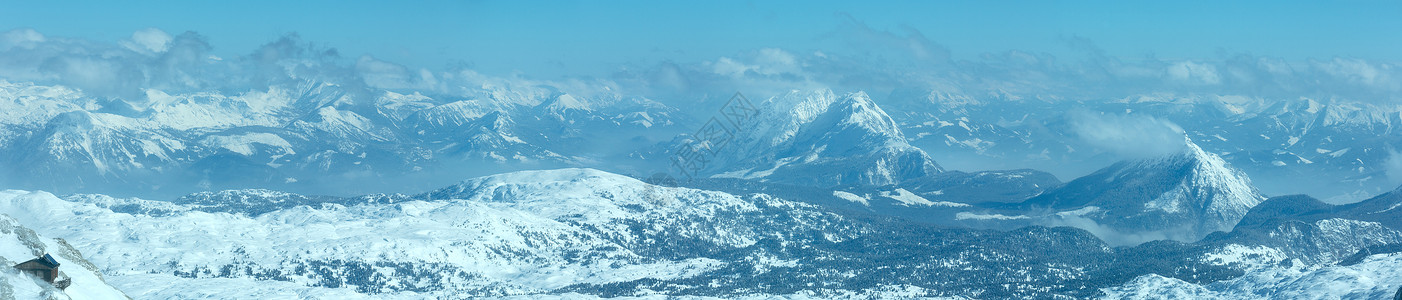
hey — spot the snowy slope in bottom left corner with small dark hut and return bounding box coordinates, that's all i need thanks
[0,214,128,299]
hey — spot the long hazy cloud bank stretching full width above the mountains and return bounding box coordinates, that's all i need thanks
[0,22,1402,110]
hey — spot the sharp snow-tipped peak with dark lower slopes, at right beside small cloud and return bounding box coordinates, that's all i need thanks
[1021,140,1265,241]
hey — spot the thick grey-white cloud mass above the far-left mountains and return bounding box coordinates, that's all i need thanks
[0,28,330,100]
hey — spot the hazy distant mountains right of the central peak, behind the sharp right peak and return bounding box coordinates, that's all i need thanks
[880,90,1402,203]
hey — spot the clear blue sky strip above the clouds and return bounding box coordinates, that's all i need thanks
[0,1,1402,77]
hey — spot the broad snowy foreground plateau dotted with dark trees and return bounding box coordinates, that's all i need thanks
[0,170,1284,297]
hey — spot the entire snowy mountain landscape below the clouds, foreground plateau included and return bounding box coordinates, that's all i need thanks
[0,76,1402,299]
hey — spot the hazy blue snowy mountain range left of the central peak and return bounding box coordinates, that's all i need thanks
[0,80,677,198]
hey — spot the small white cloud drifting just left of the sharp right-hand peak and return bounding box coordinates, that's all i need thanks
[1068,112,1186,158]
